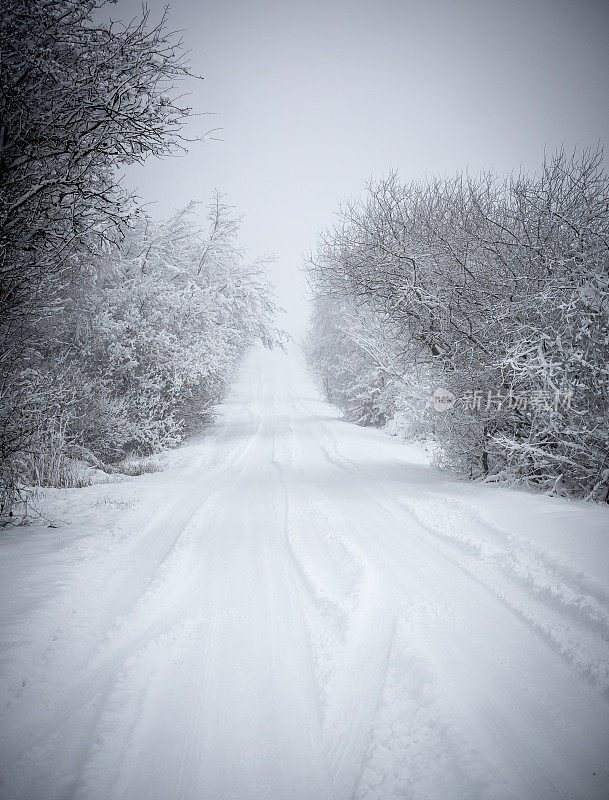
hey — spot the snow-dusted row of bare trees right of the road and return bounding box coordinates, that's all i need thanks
[306,149,609,501]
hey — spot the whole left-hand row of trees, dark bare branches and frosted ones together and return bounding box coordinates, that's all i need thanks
[0,0,277,517]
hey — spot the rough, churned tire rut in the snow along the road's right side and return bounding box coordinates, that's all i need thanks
[302,404,609,699]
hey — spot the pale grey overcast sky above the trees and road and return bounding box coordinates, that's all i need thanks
[110,0,609,333]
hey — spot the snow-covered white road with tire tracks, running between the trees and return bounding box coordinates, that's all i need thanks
[0,351,609,800]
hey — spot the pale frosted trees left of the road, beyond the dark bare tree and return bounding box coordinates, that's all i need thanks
[13,197,281,488]
